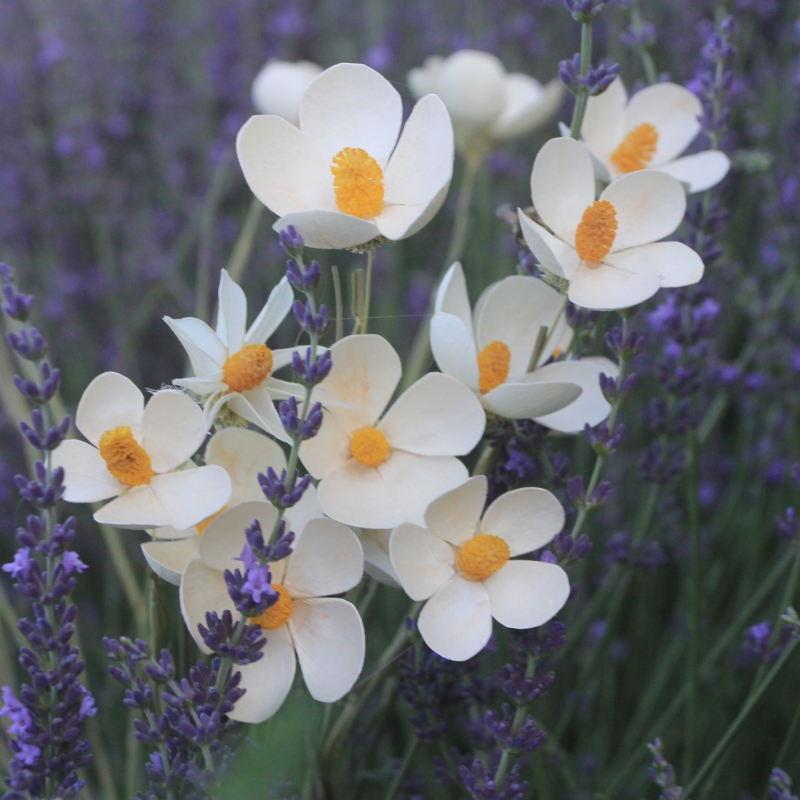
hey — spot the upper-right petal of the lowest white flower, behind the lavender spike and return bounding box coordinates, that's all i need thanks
[283,519,364,598]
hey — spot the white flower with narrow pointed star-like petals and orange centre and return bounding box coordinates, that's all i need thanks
[164,270,301,442]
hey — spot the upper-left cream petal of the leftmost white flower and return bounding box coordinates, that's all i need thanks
[75,372,144,447]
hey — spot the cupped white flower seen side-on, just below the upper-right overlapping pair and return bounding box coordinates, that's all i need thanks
[431,263,618,433]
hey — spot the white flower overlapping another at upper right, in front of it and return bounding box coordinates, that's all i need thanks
[519,138,703,310]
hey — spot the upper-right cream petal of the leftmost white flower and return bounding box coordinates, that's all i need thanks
[141,389,206,473]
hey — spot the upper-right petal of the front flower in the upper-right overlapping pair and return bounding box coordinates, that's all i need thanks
[600,169,686,253]
